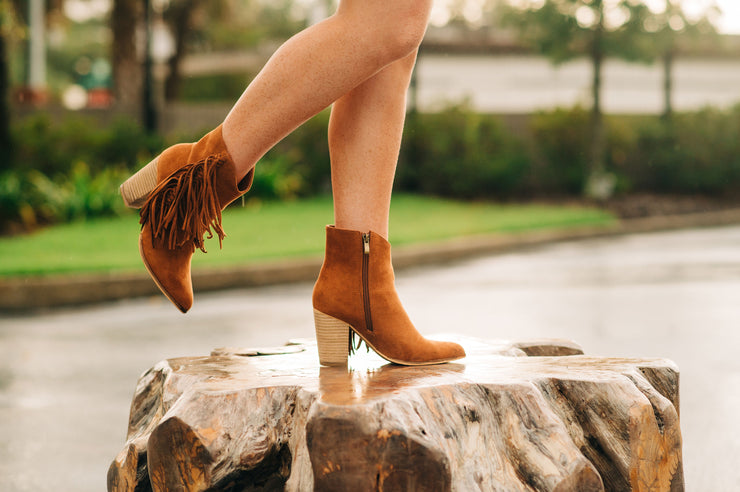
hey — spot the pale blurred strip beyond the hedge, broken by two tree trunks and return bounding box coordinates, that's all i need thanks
[418,54,740,114]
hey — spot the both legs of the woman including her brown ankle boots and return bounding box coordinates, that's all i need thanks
[121,0,465,365]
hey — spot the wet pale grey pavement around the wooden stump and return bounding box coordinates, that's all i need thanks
[0,227,740,492]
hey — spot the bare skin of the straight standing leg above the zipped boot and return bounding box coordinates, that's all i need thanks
[329,50,416,239]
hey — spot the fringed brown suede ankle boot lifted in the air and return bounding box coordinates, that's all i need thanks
[121,126,254,313]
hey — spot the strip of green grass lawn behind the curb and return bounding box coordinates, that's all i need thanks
[0,195,616,277]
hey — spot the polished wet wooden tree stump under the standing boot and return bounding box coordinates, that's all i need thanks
[108,338,683,492]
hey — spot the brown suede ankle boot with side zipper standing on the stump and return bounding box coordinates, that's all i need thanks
[313,226,465,365]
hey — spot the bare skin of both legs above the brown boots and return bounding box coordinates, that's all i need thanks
[223,0,431,238]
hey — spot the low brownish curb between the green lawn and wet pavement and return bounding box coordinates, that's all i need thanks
[0,208,740,312]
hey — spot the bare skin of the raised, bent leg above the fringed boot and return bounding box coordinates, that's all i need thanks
[223,0,431,180]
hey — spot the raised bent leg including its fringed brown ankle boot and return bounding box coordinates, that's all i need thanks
[121,0,431,312]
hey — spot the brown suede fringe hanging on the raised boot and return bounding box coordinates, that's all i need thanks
[139,155,227,253]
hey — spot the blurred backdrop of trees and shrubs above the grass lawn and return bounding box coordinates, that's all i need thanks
[0,0,740,234]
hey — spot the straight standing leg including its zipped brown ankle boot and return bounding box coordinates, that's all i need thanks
[312,50,465,365]
